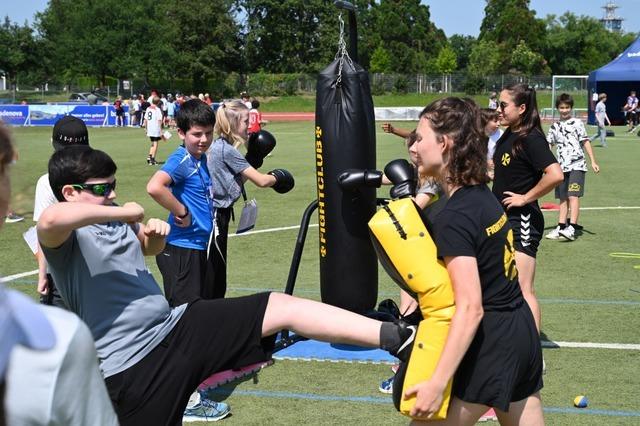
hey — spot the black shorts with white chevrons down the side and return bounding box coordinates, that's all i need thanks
[507,203,544,257]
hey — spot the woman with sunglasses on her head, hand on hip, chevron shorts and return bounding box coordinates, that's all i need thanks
[493,84,564,332]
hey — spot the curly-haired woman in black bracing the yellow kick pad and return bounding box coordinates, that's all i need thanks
[405,98,544,425]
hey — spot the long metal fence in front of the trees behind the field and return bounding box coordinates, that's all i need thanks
[0,73,560,103]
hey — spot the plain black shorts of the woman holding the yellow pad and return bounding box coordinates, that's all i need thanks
[453,300,542,411]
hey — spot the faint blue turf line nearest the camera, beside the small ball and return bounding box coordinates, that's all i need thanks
[207,389,640,417]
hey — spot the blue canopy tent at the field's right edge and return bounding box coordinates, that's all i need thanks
[587,38,640,124]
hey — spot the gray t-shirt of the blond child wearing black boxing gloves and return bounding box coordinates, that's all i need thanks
[207,138,250,208]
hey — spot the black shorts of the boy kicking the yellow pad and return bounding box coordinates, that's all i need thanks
[106,293,275,426]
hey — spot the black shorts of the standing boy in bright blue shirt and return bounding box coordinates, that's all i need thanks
[156,244,214,306]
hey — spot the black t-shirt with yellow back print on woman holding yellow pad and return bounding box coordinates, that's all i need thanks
[430,185,522,311]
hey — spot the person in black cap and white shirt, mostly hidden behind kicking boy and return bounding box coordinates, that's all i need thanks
[33,115,89,309]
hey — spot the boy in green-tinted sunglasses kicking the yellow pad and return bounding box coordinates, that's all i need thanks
[38,147,416,425]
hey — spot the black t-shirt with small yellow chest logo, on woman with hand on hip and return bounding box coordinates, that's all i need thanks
[493,129,557,201]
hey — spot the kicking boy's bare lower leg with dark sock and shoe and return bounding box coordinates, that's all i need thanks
[262,293,416,359]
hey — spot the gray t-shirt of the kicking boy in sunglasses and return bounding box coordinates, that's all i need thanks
[42,222,187,377]
